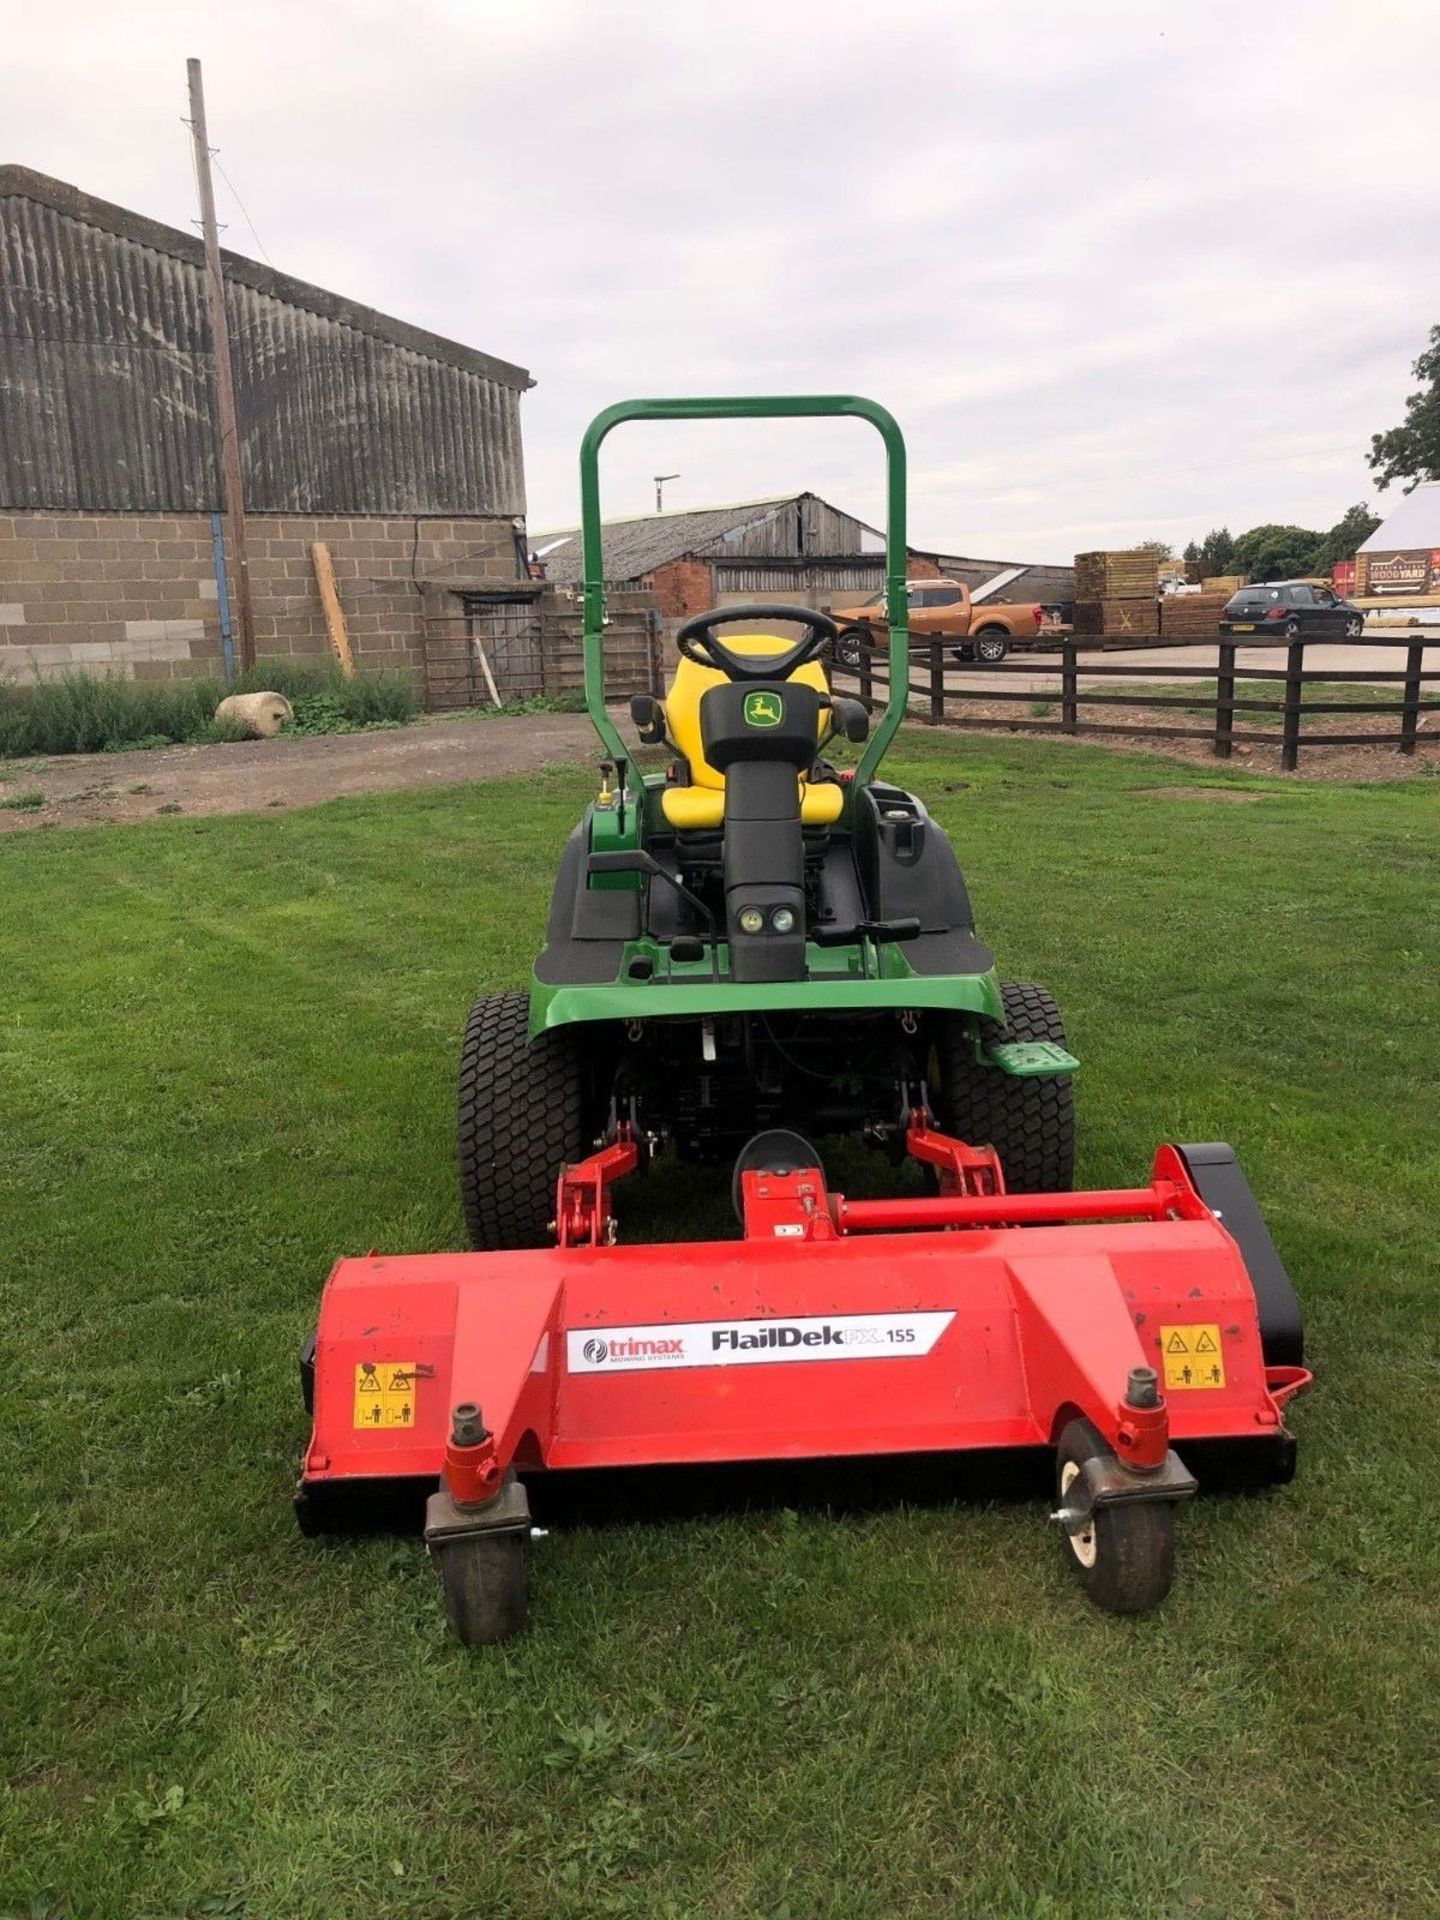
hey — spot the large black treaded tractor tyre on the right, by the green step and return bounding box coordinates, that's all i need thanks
[935,981,1075,1194]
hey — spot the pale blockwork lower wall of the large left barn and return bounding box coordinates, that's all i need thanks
[0,513,516,680]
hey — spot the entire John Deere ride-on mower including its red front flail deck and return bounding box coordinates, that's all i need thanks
[296,396,1309,1644]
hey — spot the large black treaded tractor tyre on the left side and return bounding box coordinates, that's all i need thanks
[455,993,589,1254]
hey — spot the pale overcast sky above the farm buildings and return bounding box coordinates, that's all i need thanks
[0,0,1440,561]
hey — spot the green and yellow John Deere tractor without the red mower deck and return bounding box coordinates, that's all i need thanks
[459,396,1075,1248]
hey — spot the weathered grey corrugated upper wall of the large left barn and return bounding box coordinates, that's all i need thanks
[0,167,532,516]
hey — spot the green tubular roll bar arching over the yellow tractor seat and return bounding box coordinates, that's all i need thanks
[580,394,910,787]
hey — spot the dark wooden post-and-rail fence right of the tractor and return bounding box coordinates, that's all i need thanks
[833,636,1440,772]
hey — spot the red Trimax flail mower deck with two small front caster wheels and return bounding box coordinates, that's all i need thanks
[298,1125,1309,1642]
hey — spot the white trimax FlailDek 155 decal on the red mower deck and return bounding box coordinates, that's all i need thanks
[564,1311,954,1373]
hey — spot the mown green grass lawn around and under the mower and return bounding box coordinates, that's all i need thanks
[0,739,1440,1920]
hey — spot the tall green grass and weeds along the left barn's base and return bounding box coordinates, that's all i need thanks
[0,660,419,756]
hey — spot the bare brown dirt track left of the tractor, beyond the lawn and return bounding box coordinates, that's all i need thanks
[0,714,597,833]
